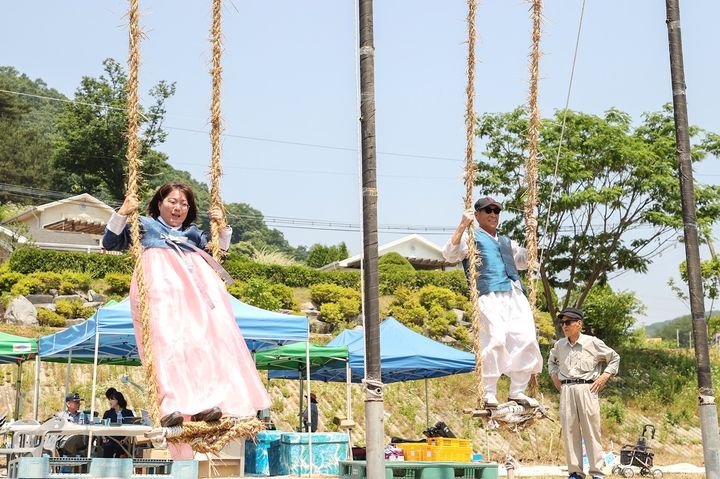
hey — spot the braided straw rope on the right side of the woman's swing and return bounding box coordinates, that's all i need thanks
[208,0,224,261]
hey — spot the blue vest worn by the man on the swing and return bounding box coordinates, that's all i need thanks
[463,230,522,295]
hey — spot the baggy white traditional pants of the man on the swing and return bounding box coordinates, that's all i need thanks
[478,284,543,397]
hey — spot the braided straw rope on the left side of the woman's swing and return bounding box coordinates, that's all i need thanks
[127,0,160,424]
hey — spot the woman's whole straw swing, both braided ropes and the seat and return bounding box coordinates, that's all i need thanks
[127,0,264,453]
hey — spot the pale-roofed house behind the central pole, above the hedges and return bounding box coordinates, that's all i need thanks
[320,234,460,271]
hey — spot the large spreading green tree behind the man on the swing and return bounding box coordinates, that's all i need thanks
[476,106,720,324]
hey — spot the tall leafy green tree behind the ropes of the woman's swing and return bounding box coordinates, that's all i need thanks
[53,58,175,201]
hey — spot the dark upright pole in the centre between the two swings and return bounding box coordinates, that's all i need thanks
[358,0,385,478]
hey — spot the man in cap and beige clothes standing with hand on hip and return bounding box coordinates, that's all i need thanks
[548,308,620,479]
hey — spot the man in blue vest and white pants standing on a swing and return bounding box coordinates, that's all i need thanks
[443,196,543,407]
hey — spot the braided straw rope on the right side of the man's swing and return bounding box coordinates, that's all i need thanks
[525,0,542,395]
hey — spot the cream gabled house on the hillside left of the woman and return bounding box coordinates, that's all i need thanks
[0,193,114,253]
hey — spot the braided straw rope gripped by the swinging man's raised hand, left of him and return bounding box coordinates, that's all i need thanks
[465,0,485,404]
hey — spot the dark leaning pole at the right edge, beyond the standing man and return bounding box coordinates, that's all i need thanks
[665,0,720,479]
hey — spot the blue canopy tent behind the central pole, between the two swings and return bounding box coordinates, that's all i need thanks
[268,317,475,426]
